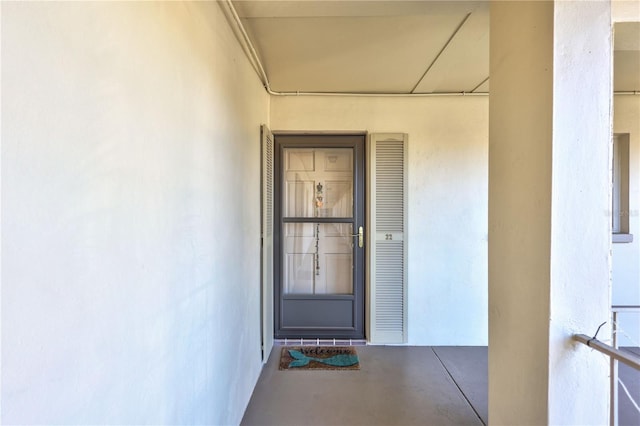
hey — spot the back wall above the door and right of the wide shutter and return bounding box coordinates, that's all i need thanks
[271,96,488,345]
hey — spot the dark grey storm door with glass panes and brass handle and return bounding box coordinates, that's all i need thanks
[274,135,365,338]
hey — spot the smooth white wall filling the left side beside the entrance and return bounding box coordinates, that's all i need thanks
[1,2,269,424]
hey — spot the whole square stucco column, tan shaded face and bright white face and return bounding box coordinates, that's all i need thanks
[489,1,612,425]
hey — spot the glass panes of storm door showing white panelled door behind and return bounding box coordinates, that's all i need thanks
[283,148,353,295]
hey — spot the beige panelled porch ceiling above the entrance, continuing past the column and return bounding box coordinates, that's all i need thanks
[232,0,640,94]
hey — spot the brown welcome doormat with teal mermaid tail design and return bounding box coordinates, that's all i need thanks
[280,346,360,370]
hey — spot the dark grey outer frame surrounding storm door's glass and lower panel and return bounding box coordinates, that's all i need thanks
[273,131,367,339]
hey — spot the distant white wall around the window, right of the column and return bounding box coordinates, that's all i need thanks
[612,96,640,346]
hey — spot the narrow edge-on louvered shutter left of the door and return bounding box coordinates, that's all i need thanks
[260,124,273,363]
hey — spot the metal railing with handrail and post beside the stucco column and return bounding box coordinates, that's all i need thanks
[573,305,640,426]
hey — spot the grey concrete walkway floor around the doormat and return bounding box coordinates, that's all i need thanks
[241,346,640,426]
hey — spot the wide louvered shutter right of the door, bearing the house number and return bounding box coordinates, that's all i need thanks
[368,133,407,344]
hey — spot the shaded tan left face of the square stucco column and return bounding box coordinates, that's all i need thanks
[488,2,553,425]
